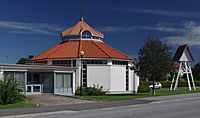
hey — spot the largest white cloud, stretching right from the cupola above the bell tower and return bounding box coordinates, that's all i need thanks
[98,21,200,46]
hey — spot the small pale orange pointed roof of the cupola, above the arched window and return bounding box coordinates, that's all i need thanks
[61,17,104,38]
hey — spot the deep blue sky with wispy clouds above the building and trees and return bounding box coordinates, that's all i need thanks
[0,0,200,63]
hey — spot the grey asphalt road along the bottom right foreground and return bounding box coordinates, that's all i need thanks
[2,93,200,118]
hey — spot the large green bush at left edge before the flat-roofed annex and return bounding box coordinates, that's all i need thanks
[0,78,23,104]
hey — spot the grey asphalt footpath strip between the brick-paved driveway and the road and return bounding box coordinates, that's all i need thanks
[0,99,152,117]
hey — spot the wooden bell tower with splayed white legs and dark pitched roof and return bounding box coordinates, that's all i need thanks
[170,44,196,90]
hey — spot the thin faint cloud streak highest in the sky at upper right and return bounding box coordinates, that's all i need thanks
[117,8,200,18]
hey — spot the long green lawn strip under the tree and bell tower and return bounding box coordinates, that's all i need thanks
[82,88,200,101]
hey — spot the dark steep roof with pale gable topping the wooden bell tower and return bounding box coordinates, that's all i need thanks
[173,44,194,61]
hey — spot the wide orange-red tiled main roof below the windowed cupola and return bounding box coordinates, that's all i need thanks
[31,40,133,61]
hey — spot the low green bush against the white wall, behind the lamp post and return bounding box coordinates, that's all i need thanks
[75,85,106,96]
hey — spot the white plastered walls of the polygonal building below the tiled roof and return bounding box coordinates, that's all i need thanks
[76,60,139,93]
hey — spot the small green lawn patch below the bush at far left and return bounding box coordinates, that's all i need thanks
[0,99,36,109]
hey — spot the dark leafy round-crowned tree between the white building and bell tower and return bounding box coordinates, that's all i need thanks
[137,37,171,95]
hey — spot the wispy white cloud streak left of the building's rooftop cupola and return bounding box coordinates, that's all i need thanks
[0,21,62,35]
